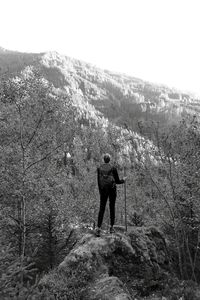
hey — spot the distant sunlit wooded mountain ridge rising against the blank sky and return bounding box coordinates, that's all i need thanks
[0,48,200,131]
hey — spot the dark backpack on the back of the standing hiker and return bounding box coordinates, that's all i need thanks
[99,165,115,189]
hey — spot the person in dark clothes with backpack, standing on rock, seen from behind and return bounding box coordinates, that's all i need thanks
[96,153,126,236]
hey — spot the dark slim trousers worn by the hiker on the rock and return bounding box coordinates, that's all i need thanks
[97,188,117,227]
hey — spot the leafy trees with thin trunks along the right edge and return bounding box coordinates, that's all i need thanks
[137,118,200,281]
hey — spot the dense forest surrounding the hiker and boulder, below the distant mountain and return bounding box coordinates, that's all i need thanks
[0,64,200,300]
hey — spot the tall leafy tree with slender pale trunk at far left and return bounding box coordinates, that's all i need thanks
[0,68,74,260]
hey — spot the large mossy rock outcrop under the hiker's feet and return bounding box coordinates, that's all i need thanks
[41,227,170,300]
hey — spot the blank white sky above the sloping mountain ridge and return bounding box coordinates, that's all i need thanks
[0,0,200,95]
